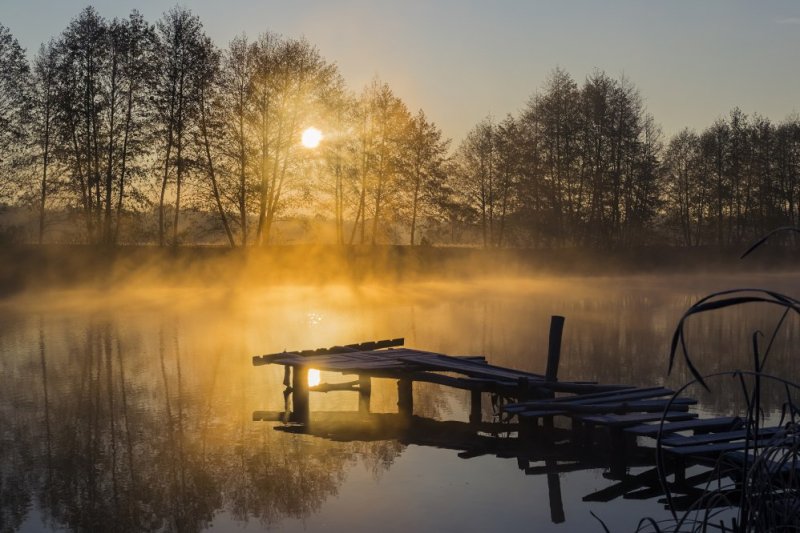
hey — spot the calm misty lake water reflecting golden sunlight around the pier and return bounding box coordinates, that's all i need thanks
[0,275,800,532]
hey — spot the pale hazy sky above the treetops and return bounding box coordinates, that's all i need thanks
[0,0,800,140]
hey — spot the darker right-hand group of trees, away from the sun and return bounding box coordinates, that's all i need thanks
[454,69,800,247]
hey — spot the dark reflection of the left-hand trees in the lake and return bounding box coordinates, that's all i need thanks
[0,310,418,531]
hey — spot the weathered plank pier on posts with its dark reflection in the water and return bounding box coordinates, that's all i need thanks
[253,317,800,522]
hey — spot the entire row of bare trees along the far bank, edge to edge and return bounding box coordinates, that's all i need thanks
[0,7,800,247]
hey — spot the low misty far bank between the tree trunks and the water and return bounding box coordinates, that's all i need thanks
[0,245,800,295]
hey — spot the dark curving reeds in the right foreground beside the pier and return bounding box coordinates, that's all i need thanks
[593,227,800,533]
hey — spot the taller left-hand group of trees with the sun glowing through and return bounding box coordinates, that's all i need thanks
[0,7,448,246]
